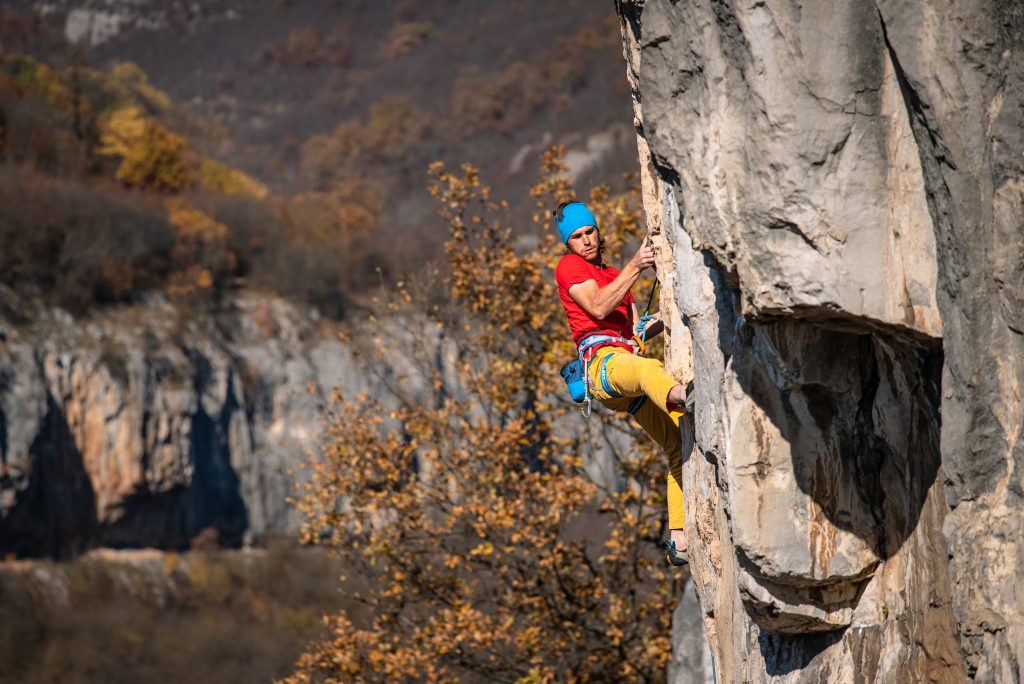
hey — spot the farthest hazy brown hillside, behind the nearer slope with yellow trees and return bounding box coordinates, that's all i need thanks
[22,0,636,218]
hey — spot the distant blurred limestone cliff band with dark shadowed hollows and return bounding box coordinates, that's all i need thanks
[0,293,459,557]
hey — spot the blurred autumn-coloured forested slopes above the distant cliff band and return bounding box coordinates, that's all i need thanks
[0,0,636,318]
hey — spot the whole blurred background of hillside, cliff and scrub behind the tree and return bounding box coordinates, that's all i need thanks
[0,0,665,682]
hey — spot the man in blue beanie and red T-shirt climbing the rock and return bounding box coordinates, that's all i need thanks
[554,202,689,565]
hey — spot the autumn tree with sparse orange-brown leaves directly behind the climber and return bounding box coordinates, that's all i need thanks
[288,149,674,683]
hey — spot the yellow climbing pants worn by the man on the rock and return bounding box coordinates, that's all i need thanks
[587,347,686,529]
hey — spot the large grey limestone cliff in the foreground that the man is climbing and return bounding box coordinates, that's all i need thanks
[616,0,1024,682]
